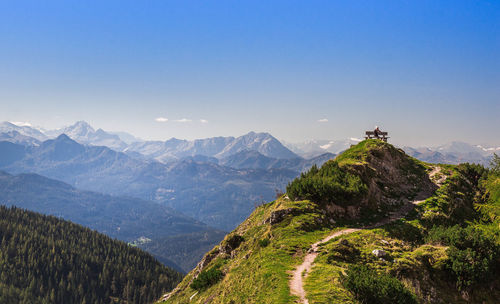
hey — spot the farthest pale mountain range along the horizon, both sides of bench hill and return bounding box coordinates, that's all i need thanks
[0,121,500,168]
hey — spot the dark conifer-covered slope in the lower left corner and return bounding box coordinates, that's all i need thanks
[0,206,181,304]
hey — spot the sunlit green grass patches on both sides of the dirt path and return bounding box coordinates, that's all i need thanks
[161,140,498,303]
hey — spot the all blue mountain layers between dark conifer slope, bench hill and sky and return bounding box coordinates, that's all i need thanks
[0,122,335,272]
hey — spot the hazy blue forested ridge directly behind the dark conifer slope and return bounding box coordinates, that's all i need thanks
[0,171,209,241]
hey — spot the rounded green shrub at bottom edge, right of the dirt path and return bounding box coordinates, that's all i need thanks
[341,265,418,304]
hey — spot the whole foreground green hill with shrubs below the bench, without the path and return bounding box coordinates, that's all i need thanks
[160,140,500,303]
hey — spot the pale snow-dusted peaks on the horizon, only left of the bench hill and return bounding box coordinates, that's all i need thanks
[0,121,298,163]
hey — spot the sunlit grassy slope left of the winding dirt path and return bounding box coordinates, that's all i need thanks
[163,198,331,303]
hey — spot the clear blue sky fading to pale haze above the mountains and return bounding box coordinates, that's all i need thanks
[0,0,500,145]
